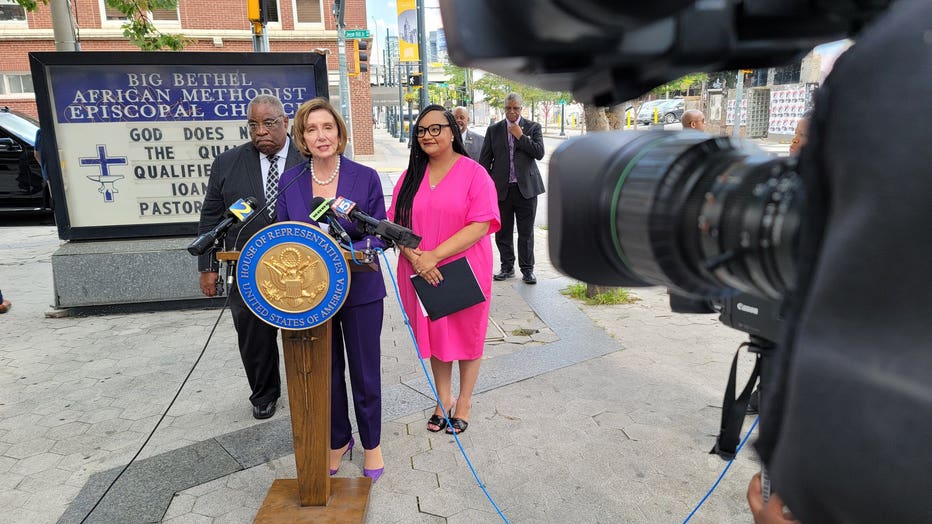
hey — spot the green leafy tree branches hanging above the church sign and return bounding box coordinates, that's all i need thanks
[16,0,191,51]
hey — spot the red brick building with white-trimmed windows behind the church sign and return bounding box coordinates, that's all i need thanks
[0,0,373,155]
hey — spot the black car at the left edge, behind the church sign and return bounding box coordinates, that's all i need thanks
[0,107,52,213]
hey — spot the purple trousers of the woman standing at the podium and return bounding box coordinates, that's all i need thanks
[330,299,383,449]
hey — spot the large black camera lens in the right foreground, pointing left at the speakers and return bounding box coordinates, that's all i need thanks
[549,131,800,299]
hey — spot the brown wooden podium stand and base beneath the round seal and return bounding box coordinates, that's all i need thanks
[217,238,376,524]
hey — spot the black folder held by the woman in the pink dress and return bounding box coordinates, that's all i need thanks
[411,257,485,320]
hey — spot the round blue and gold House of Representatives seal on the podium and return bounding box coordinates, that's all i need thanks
[236,222,350,330]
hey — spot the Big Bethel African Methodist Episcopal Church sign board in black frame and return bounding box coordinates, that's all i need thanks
[30,52,328,240]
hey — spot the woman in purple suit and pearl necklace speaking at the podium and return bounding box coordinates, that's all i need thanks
[276,98,385,482]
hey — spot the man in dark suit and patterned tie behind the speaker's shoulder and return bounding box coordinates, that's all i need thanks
[198,95,304,419]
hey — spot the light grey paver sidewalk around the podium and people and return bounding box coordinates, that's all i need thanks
[0,130,757,523]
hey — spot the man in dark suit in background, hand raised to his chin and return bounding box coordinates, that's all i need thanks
[479,93,544,284]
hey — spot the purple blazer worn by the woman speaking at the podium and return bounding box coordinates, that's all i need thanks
[275,156,386,307]
